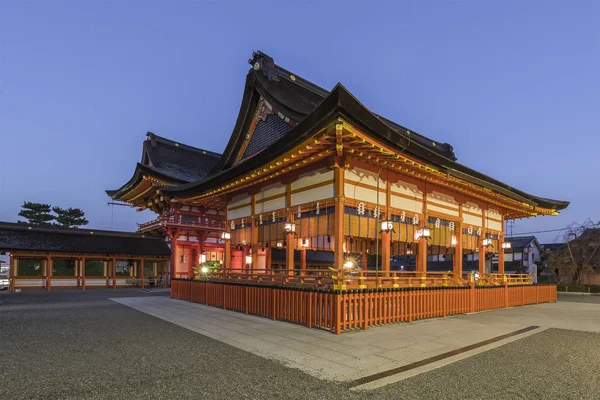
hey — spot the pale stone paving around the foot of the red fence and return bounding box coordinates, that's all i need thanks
[113,297,600,389]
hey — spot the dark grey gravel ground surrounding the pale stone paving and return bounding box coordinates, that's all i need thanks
[0,290,600,400]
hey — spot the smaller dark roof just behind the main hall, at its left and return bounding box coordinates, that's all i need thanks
[142,132,221,182]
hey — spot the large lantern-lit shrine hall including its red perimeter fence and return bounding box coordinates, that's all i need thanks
[107,52,569,333]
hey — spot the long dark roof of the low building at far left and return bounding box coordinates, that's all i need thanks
[0,222,171,257]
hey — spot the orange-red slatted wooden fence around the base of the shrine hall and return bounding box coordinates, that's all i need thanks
[171,279,556,333]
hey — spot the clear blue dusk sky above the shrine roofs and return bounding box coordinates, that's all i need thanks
[0,0,600,252]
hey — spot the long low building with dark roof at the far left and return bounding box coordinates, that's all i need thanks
[0,222,171,291]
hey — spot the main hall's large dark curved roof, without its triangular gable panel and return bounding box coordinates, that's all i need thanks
[161,52,569,214]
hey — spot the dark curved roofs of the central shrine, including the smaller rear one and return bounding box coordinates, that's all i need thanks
[107,51,569,216]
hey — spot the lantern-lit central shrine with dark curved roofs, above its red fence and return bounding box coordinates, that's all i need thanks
[107,51,569,288]
